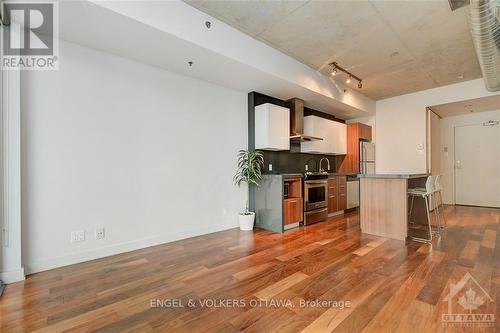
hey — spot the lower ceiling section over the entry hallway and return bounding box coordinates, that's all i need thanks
[430,95,500,118]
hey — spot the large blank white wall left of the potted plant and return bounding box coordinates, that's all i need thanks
[22,42,247,272]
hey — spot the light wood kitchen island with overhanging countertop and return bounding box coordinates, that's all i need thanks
[358,174,428,240]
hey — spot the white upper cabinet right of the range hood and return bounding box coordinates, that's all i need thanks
[300,116,347,155]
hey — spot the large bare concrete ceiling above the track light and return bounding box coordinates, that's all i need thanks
[187,0,481,100]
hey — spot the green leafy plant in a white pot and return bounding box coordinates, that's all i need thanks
[233,149,264,231]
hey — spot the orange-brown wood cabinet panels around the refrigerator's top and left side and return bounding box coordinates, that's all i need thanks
[337,123,372,173]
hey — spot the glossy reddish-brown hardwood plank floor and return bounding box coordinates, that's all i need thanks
[0,207,500,333]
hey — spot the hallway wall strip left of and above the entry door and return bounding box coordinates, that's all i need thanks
[441,110,500,204]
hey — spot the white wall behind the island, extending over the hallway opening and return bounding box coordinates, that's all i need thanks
[376,79,495,173]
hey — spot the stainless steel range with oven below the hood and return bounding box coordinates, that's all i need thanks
[304,172,328,225]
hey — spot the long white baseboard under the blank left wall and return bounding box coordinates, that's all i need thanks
[25,225,237,274]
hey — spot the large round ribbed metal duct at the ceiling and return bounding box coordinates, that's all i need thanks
[469,0,500,91]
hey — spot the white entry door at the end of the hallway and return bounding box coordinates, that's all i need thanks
[455,124,500,207]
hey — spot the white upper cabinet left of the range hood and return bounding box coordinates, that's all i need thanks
[255,103,290,150]
